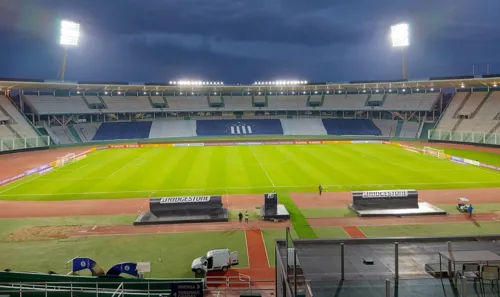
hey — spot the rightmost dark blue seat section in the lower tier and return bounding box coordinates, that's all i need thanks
[323,119,382,136]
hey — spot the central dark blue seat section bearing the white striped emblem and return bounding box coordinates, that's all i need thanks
[196,119,283,136]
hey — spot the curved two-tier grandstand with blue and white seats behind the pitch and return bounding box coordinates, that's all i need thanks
[0,77,500,144]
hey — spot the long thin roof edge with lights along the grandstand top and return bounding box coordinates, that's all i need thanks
[0,75,500,92]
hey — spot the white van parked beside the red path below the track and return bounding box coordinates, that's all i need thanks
[191,249,239,274]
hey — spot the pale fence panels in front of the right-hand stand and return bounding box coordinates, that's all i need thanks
[428,130,500,145]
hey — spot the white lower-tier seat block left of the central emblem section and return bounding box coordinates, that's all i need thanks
[149,120,196,138]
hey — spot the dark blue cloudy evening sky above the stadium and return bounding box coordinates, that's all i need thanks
[0,0,500,83]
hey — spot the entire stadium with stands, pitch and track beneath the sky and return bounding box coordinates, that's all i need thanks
[0,19,500,297]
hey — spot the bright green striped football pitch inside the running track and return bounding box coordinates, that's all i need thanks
[0,144,500,200]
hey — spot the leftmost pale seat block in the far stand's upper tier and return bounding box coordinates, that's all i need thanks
[24,95,94,114]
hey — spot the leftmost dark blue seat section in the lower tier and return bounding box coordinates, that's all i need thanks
[92,122,153,140]
